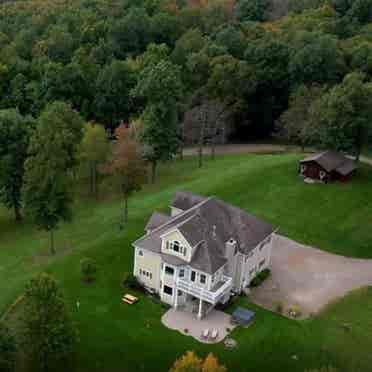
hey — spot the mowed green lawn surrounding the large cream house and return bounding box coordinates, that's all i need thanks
[0,155,372,372]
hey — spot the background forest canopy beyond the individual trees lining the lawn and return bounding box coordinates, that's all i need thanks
[0,0,372,141]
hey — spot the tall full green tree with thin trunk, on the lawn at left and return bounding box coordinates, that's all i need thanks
[23,102,83,254]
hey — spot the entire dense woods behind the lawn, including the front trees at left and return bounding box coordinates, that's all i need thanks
[0,0,372,227]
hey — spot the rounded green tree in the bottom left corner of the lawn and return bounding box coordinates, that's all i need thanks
[23,273,77,372]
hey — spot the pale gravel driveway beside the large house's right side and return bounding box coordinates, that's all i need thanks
[251,235,372,317]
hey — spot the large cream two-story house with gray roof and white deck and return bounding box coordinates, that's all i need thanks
[133,192,273,318]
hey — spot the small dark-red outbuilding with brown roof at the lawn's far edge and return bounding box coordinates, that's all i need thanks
[300,151,358,183]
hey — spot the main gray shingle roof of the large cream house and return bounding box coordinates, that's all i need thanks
[134,194,273,274]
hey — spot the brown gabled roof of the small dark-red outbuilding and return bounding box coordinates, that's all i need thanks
[301,151,358,176]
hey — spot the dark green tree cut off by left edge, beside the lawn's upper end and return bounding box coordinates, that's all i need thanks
[0,109,33,221]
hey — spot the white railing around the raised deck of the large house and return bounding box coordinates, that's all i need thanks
[177,275,232,305]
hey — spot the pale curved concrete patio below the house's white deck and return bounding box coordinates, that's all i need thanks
[161,309,235,344]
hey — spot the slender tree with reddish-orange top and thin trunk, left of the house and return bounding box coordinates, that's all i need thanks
[106,125,146,224]
